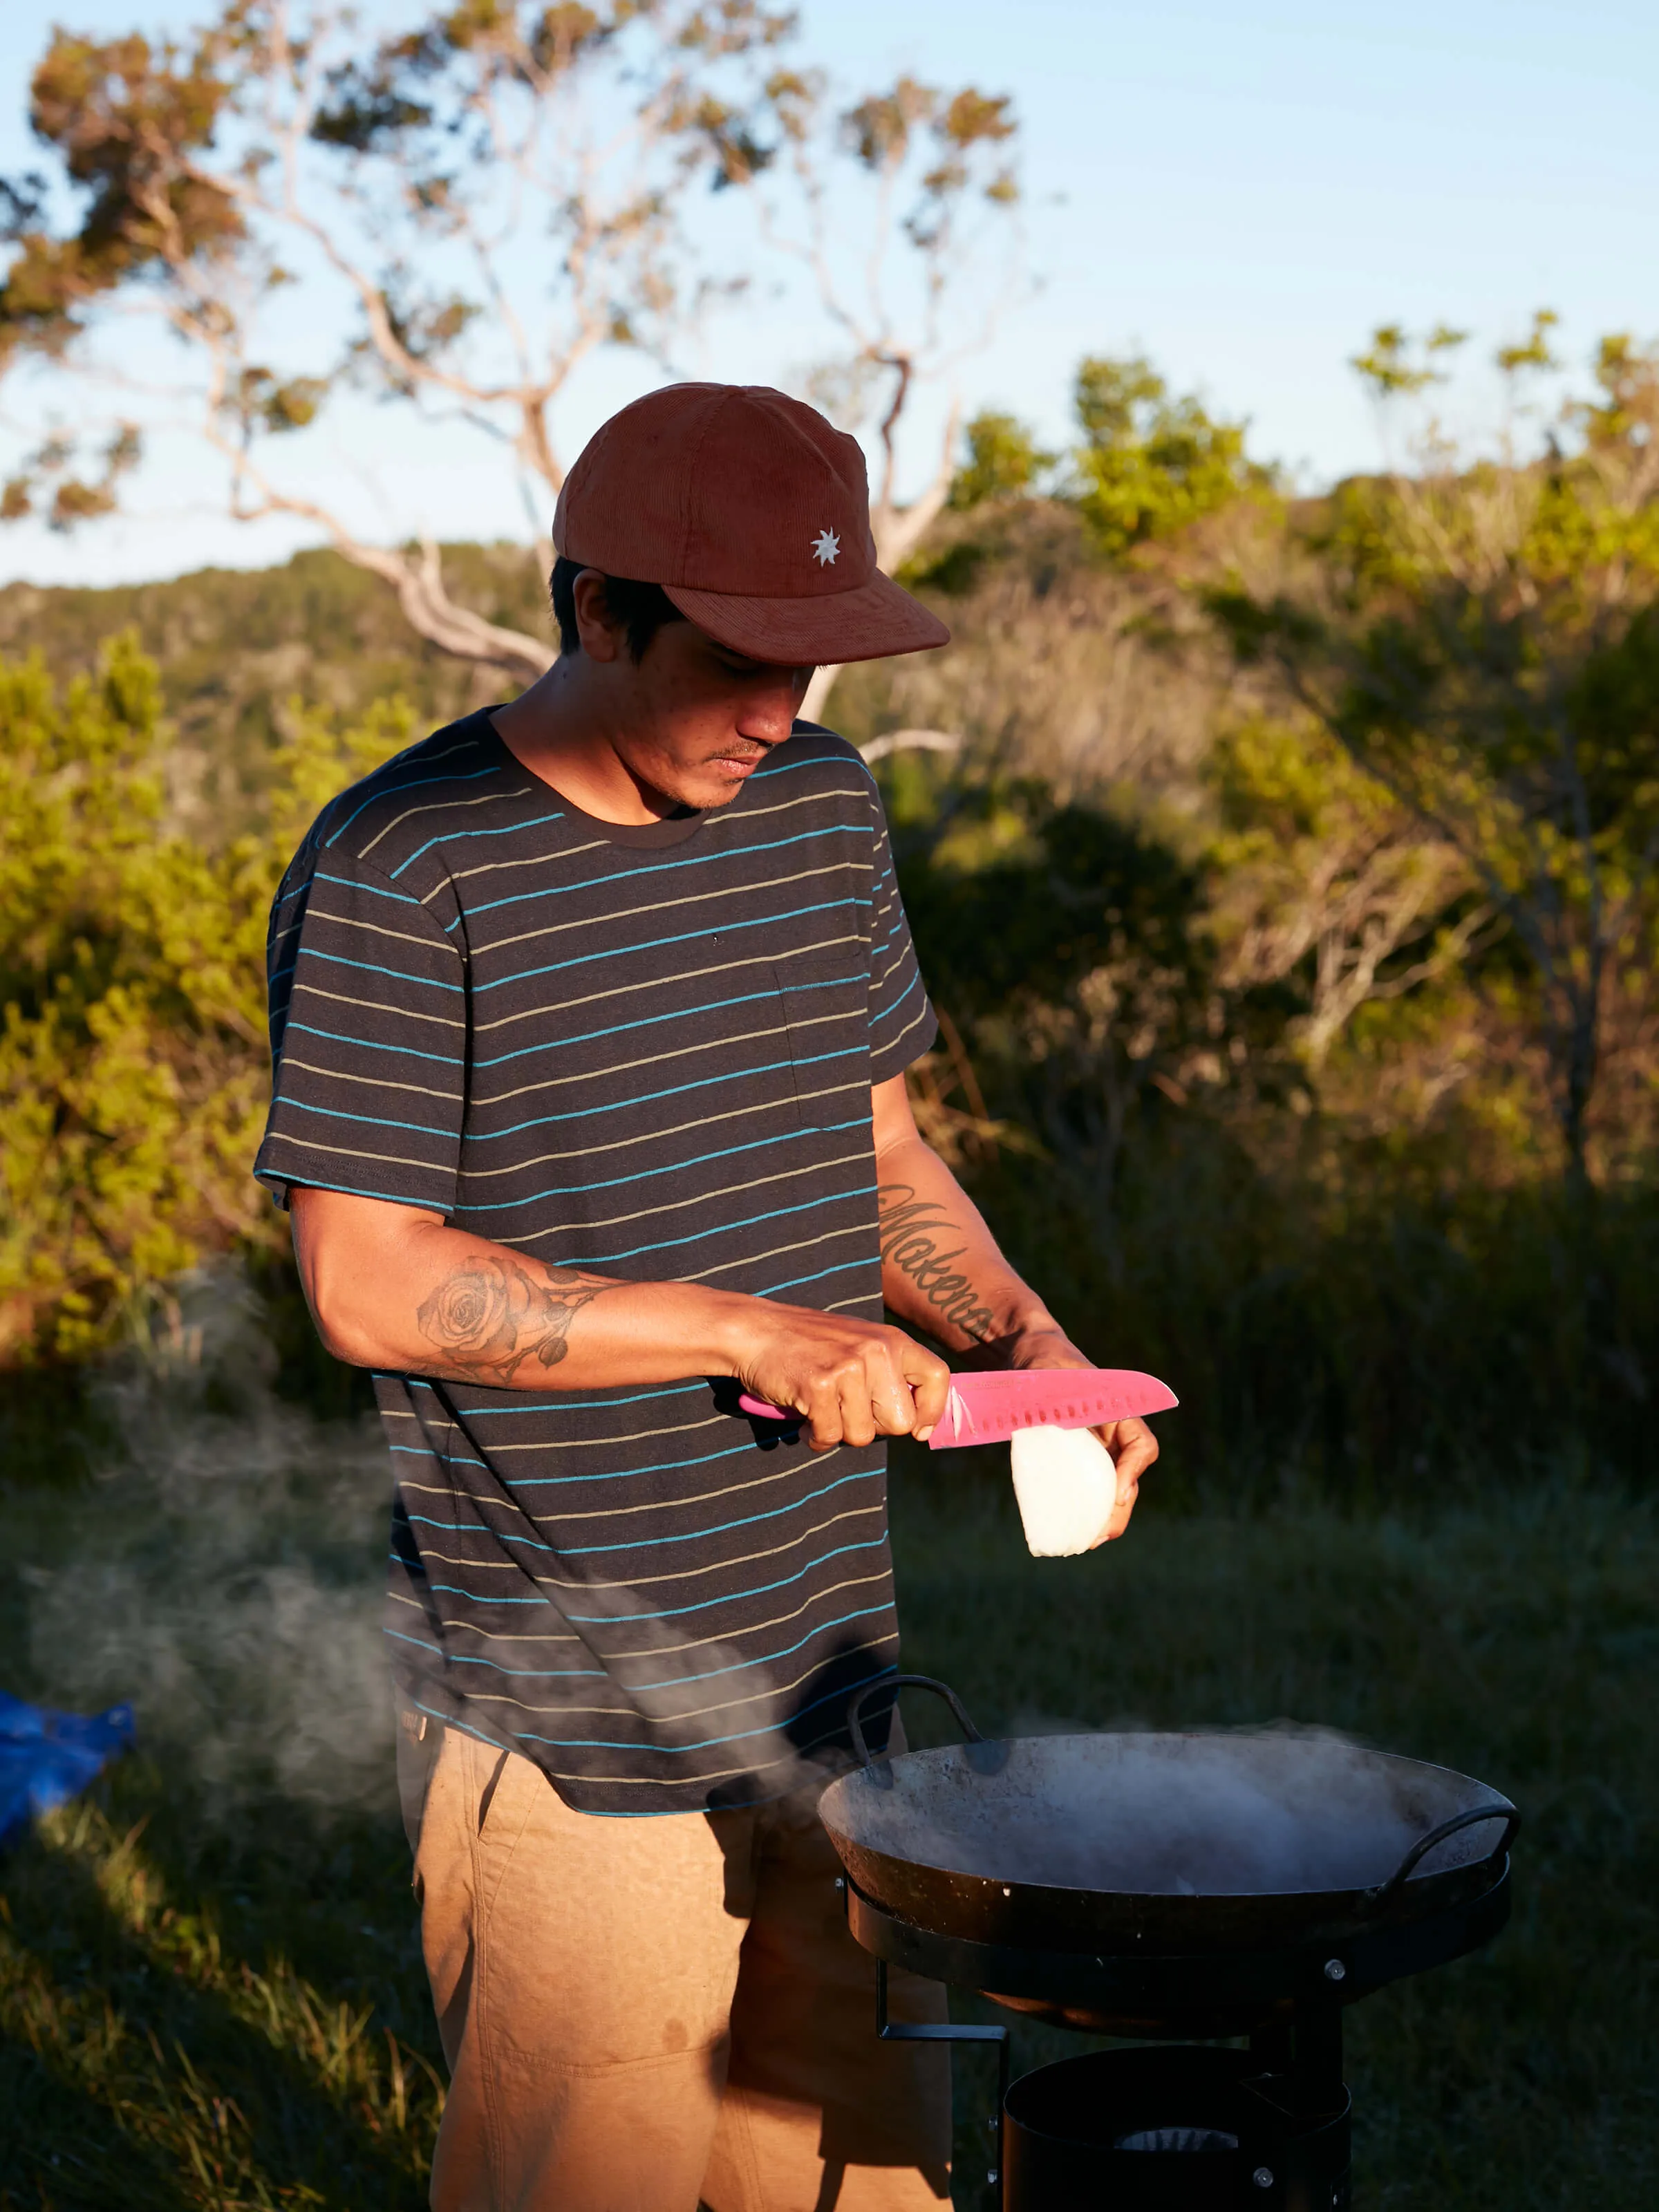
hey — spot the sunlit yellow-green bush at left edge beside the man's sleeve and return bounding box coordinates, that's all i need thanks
[0,639,402,1365]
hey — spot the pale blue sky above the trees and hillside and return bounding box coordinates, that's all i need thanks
[0,0,1659,579]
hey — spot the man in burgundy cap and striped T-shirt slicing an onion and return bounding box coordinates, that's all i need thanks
[259,385,1157,2212]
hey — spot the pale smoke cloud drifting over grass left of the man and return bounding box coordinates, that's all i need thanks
[17,1279,394,1814]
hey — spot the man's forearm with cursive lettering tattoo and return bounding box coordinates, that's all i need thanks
[876,1137,1055,1351]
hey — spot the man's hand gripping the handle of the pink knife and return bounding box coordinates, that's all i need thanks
[734,1298,951,1451]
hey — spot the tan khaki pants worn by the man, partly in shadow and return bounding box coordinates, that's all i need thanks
[398,1725,951,2212]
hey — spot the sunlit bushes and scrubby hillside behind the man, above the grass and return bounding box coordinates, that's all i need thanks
[0,332,1659,1495]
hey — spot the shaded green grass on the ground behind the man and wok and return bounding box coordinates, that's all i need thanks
[0,1405,1659,2212]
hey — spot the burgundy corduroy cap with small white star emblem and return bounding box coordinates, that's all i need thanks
[553,385,951,668]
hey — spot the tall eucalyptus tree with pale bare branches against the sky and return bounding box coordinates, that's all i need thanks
[0,0,1018,679]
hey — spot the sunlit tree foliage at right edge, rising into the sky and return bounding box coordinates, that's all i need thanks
[1212,319,1659,1174]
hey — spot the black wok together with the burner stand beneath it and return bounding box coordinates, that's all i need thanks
[818,1674,1519,2212]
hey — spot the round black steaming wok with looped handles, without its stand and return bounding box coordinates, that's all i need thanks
[818,1674,1519,1956]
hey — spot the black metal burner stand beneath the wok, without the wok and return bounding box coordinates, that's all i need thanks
[845,1862,1508,2212]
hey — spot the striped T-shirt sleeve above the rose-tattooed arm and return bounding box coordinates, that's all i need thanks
[254,845,467,1215]
